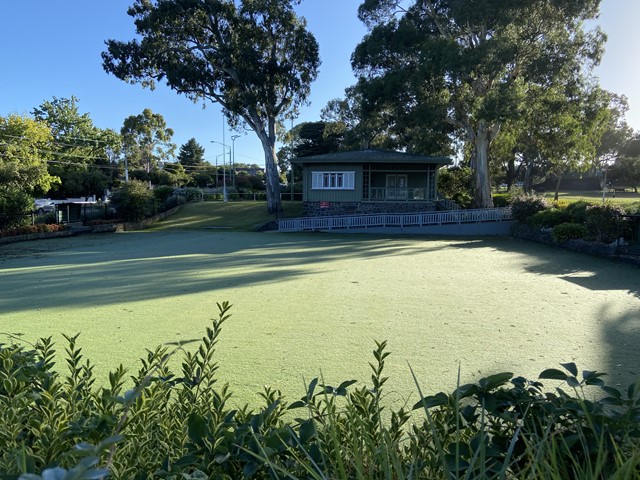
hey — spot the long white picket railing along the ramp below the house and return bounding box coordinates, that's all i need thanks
[278,207,511,232]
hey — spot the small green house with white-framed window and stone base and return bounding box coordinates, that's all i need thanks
[292,150,451,216]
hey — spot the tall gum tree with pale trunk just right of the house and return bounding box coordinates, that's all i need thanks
[352,0,605,207]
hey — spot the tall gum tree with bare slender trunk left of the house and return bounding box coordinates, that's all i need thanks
[102,0,320,213]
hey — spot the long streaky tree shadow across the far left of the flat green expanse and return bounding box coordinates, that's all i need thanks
[0,232,450,314]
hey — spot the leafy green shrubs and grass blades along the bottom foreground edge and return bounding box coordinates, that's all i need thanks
[0,303,640,480]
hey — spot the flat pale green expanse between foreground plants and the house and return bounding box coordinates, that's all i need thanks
[0,225,640,402]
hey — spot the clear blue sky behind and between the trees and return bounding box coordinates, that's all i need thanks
[0,0,640,165]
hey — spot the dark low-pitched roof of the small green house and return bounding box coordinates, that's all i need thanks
[292,150,452,165]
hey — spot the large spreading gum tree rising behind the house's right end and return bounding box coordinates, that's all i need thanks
[352,0,606,207]
